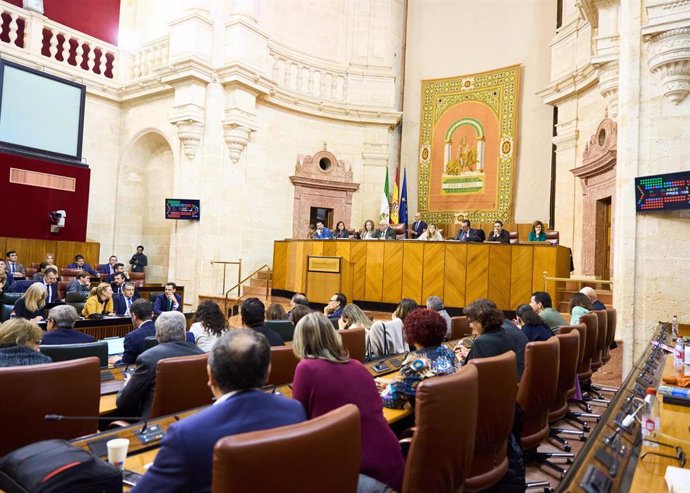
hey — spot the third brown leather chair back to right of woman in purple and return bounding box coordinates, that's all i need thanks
[517,337,560,449]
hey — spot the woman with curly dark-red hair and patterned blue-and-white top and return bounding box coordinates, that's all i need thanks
[377,309,460,409]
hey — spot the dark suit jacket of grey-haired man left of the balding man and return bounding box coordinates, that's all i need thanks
[116,341,204,418]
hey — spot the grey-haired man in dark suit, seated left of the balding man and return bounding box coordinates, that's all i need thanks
[115,312,204,418]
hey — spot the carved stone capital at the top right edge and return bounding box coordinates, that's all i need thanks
[646,27,690,104]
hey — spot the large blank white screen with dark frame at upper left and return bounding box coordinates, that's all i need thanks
[0,60,86,161]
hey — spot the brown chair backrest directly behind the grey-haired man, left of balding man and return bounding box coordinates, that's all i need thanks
[151,353,213,418]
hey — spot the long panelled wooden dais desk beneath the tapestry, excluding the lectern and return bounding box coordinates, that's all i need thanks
[273,240,570,310]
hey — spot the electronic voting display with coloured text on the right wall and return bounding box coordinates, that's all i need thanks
[635,171,690,212]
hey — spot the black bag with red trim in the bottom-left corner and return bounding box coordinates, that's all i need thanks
[0,440,122,493]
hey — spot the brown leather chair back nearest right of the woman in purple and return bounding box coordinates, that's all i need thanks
[402,365,479,493]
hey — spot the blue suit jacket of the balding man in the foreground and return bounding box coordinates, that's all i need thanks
[132,390,307,493]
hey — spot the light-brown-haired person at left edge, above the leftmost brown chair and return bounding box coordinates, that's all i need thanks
[0,318,53,368]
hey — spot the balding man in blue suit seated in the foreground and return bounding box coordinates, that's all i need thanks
[132,329,307,492]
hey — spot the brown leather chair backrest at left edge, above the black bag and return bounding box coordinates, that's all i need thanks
[0,358,101,456]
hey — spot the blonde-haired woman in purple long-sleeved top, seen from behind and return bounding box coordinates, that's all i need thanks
[292,312,405,491]
